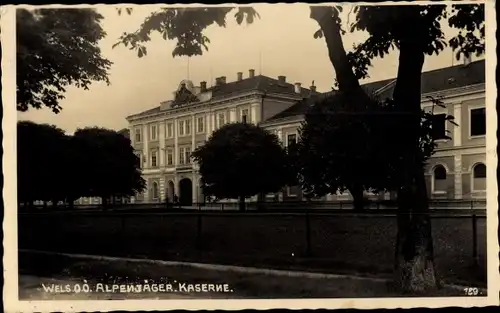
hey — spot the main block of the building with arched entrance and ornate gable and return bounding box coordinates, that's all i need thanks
[127,69,316,204]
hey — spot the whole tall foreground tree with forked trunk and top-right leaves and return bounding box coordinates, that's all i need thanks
[311,4,484,291]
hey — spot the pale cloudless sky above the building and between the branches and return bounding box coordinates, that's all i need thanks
[18,4,480,134]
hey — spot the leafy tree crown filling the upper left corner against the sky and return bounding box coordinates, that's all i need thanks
[16,9,112,113]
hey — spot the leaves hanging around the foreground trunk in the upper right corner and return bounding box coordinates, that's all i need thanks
[346,4,485,78]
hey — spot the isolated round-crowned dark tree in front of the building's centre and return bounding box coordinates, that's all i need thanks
[192,123,289,210]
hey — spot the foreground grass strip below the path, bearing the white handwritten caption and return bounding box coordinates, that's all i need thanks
[19,249,472,300]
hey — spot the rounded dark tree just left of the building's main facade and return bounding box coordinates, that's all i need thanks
[74,127,146,206]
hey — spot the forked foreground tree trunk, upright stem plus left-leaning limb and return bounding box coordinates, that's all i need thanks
[310,6,437,292]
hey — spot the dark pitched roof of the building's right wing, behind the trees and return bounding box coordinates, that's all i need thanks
[264,60,486,123]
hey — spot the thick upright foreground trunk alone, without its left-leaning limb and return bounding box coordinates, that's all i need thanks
[394,6,438,293]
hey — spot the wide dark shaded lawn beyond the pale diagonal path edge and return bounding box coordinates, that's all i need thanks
[19,213,486,286]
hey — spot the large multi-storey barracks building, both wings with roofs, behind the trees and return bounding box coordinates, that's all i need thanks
[127,60,486,204]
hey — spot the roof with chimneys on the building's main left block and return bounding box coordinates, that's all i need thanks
[130,75,311,117]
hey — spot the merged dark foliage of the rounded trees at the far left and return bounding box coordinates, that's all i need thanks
[17,121,145,205]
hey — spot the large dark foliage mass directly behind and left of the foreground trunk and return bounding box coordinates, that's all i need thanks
[294,92,454,197]
